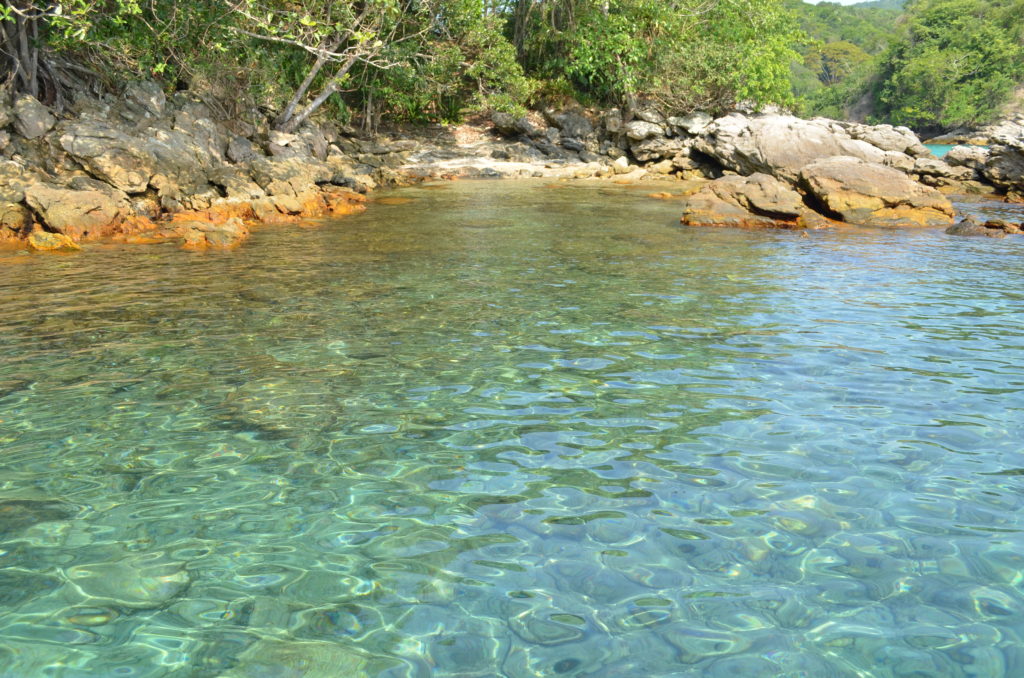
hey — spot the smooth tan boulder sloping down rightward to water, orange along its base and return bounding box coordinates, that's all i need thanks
[800,157,953,228]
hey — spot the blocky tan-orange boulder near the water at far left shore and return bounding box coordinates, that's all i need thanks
[25,183,125,241]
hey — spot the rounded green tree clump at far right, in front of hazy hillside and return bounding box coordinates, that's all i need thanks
[878,0,1024,127]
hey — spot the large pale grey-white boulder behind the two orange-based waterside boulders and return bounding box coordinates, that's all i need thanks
[694,114,886,182]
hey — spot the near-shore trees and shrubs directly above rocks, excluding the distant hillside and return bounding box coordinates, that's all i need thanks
[0,0,798,129]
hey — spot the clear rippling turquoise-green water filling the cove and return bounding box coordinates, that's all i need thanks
[0,182,1024,678]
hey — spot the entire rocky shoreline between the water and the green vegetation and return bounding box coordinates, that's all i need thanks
[0,82,1024,250]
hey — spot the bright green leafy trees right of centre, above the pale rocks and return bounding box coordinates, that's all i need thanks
[511,0,802,112]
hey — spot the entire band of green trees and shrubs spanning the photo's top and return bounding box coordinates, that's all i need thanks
[0,0,1024,130]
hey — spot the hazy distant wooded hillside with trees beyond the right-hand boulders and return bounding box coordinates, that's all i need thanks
[791,0,1024,129]
